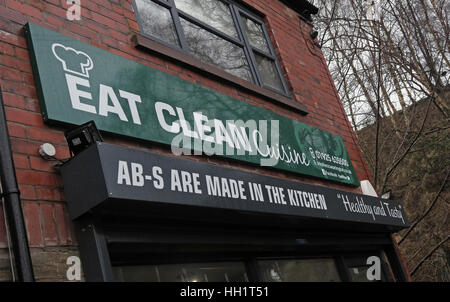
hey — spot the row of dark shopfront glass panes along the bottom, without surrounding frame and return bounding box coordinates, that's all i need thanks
[113,255,393,282]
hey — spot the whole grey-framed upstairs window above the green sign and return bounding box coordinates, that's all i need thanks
[133,0,288,96]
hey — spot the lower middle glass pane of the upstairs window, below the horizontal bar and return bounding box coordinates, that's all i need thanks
[180,18,252,81]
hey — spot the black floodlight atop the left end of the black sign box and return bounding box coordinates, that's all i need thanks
[64,121,103,156]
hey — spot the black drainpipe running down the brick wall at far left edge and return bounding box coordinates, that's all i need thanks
[0,90,34,282]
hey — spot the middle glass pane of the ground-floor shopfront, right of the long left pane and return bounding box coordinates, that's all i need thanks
[258,259,341,282]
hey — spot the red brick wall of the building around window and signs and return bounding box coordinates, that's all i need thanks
[0,0,370,272]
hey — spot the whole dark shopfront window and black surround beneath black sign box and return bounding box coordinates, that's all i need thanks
[87,214,404,282]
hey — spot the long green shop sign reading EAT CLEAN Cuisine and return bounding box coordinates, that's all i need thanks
[25,23,359,186]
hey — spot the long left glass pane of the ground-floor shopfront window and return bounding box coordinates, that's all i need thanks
[113,262,248,282]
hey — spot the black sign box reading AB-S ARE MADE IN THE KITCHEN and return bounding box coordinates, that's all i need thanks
[61,143,408,232]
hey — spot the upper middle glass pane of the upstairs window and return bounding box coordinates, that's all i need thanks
[175,0,237,38]
